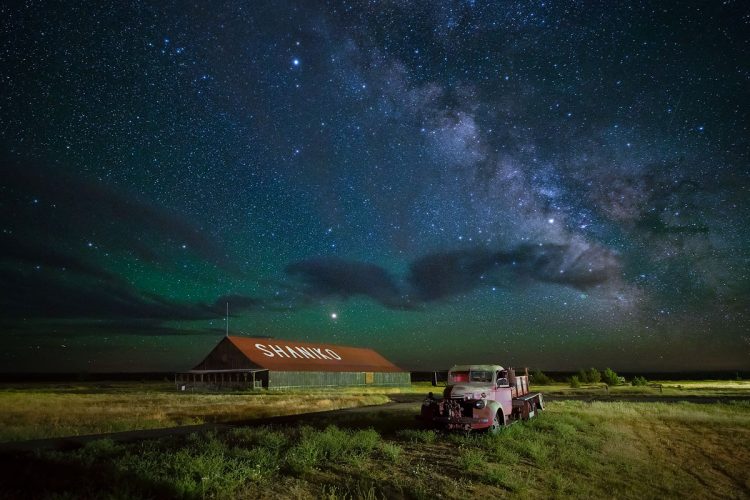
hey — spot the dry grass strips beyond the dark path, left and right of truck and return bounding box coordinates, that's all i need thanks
[0,380,750,442]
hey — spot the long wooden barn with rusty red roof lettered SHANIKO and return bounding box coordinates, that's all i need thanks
[175,337,410,389]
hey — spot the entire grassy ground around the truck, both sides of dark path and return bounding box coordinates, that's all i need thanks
[0,381,750,499]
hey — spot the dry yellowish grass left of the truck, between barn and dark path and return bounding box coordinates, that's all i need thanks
[0,383,389,441]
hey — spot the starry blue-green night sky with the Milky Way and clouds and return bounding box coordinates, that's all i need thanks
[0,0,750,372]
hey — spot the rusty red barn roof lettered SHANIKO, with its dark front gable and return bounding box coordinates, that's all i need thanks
[194,337,403,372]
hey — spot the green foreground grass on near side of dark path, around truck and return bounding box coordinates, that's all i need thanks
[0,383,750,498]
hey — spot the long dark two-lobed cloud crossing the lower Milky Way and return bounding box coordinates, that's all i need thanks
[286,240,622,309]
